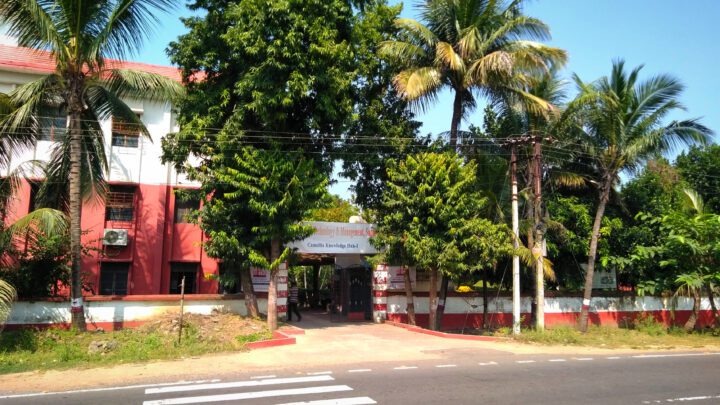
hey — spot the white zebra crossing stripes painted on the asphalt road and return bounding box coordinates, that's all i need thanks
[143,371,377,405]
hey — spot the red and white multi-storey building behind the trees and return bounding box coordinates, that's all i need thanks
[0,34,218,295]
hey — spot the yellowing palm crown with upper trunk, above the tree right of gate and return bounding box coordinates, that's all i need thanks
[380,0,567,147]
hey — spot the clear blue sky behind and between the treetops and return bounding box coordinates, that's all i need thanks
[132,0,720,196]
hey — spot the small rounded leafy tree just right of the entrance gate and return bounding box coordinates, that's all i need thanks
[378,153,486,329]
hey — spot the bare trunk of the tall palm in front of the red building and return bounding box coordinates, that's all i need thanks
[68,79,87,331]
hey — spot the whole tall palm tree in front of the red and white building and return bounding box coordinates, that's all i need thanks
[0,0,182,330]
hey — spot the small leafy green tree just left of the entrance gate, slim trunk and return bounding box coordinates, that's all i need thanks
[191,147,328,330]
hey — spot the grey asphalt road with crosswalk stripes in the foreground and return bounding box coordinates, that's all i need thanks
[0,350,720,405]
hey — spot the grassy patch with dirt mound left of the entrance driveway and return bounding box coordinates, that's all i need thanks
[0,314,271,374]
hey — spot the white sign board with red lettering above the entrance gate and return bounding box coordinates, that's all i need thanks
[287,221,378,255]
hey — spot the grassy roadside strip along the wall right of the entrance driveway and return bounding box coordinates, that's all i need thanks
[498,323,720,349]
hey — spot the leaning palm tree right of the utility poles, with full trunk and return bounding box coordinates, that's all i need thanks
[568,60,712,332]
